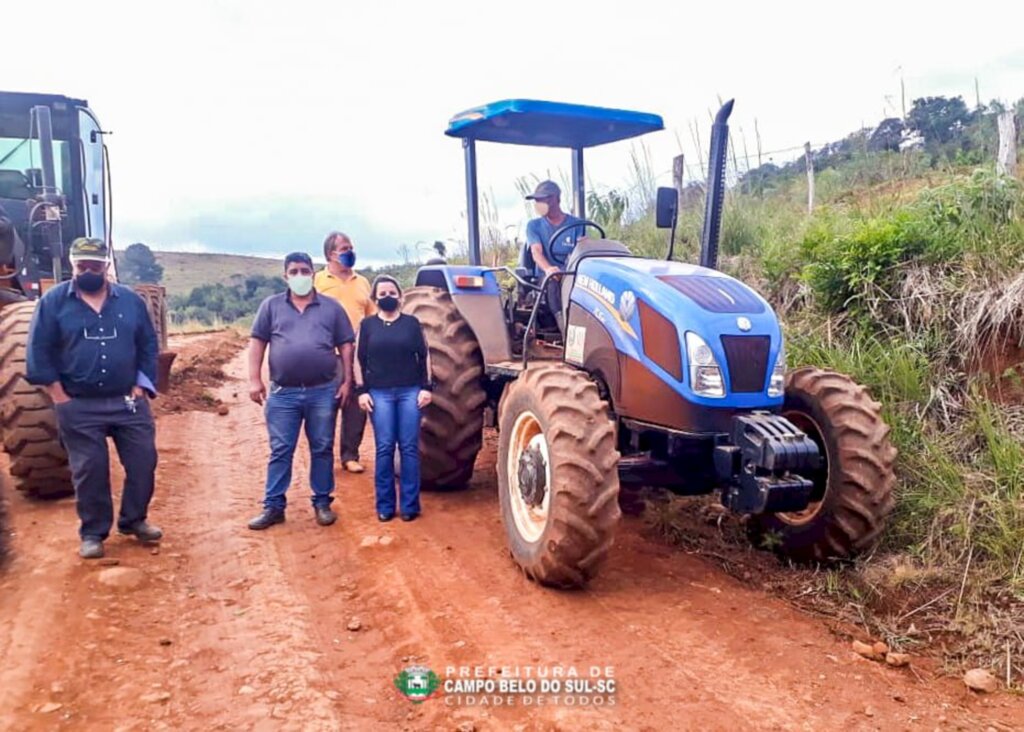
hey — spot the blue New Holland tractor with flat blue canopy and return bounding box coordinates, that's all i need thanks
[404,99,896,587]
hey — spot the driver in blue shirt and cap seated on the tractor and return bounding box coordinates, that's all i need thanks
[526,180,586,333]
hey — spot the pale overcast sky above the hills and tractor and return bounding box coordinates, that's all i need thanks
[0,0,1024,262]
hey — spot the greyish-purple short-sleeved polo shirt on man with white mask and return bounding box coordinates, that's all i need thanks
[251,291,355,386]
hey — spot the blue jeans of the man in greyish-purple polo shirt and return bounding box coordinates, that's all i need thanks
[263,382,338,511]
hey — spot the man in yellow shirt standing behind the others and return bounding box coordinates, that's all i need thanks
[313,231,377,473]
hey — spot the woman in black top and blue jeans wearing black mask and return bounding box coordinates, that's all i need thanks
[355,275,430,521]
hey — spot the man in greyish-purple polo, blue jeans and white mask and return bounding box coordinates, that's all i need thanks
[249,252,355,531]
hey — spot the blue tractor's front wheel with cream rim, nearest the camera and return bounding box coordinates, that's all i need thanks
[497,363,622,588]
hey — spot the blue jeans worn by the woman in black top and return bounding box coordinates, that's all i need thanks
[370,386,420,515]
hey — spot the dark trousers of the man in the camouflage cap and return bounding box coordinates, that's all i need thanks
[55,396,157,541]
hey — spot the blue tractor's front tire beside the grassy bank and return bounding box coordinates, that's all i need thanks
[748,368,896,562]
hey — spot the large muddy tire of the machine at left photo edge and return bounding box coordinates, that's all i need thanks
[0,302,74,499]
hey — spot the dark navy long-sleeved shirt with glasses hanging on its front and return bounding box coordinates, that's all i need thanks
[27,281,160,397]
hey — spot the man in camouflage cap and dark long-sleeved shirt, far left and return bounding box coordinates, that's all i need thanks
[27,238,163,559]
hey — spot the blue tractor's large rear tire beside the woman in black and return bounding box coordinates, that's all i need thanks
[402,287,485,489]
